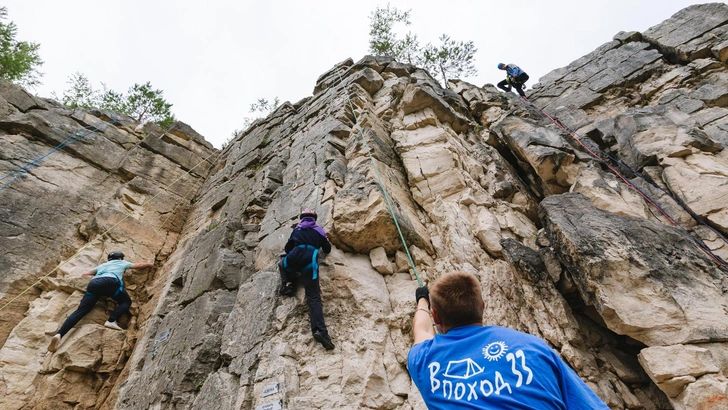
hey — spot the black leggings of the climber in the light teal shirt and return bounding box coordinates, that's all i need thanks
[58,277,131,337]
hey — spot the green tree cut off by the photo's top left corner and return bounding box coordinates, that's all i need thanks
[0,7,43,88]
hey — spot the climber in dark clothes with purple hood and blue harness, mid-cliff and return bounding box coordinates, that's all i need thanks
[278,209,334,350]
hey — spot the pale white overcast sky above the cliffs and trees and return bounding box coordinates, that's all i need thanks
[2,0,696,148]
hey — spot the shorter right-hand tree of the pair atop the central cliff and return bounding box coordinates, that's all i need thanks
[422,34,478,84]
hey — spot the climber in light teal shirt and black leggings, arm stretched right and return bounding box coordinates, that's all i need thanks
[48,251,154,352]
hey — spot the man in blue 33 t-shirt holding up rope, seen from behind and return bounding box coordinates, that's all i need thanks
[407,272,609,410]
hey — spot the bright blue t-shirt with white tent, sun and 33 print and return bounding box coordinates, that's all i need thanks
[407,325,609,410]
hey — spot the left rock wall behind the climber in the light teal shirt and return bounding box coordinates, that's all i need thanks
[0,81,215,410]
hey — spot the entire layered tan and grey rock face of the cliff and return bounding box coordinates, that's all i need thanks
[0,3,728,410]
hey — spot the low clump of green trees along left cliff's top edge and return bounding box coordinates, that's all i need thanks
[54,72,176,127]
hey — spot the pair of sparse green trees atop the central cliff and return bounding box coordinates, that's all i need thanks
[369,4,478,86]
